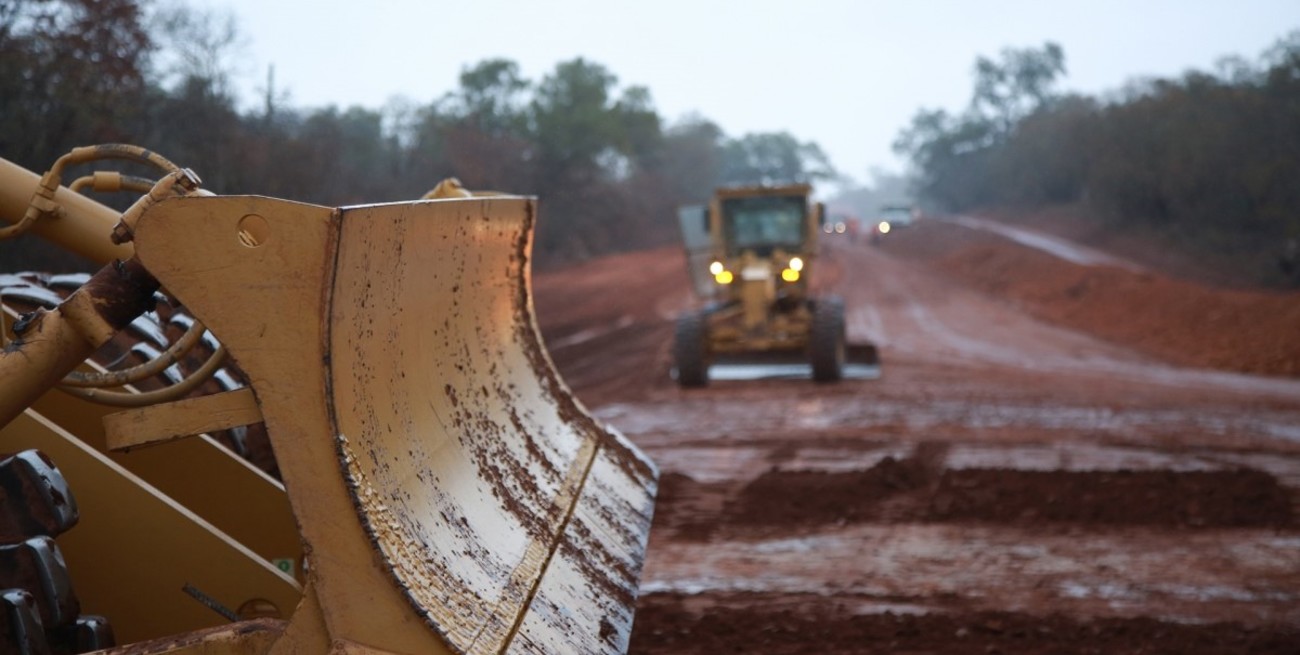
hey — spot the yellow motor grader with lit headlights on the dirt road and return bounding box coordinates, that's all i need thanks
[672,185,879,387]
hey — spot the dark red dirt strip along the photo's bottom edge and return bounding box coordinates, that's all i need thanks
[628,594,1300,655]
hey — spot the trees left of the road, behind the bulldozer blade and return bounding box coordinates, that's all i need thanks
[0,0,836,270]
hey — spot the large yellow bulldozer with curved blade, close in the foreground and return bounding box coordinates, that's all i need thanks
[0,144,657,655]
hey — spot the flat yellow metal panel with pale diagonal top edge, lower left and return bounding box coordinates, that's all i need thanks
[0,411,302,643]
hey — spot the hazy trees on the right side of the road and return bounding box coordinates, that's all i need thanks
[894,31,1300,286]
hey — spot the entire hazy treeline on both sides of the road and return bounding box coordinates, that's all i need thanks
[0,0,1300,286]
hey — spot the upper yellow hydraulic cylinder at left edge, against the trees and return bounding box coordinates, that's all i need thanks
[0,159,131,264]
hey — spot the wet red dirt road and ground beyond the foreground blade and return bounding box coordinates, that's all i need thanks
[534,224,1300,654]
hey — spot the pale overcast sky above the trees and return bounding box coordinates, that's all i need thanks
[205,0,1300,181]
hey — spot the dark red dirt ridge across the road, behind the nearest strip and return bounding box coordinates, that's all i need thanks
[655,456,1295,541]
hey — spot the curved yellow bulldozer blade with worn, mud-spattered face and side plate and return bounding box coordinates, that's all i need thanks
[135,196,657,652]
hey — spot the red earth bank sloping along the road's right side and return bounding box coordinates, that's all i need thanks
[887,224,1300,376]
